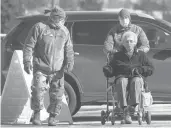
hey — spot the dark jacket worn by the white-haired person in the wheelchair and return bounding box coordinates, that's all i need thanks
[109,49,154,77]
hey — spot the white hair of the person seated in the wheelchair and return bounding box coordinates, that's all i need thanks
[122,31,138,44]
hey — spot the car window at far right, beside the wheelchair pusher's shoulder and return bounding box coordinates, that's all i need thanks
[137,23,171,49]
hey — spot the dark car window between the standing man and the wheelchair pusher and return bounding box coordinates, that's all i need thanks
[73,21,116,45]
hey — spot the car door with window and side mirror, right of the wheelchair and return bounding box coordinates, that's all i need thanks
[135,23,171,102]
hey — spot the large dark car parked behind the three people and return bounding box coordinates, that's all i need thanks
[1,11,171,115]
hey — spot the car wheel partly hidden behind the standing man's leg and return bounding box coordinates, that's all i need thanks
[64,81,77,115]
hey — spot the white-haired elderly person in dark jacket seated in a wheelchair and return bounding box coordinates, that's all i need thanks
[103,31,154,124]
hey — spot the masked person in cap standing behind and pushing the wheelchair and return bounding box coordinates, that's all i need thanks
[104,9,150,55]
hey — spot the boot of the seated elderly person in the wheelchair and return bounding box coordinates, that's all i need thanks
[121,108,132,124]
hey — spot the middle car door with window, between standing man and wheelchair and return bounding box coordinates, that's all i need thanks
[72,21,116,102]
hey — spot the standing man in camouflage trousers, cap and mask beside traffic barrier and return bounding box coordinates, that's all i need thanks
[23,7,74,126]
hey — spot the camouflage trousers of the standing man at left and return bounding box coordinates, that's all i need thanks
[31,72,64,115]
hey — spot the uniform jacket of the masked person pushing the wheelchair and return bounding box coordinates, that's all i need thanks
[104,24,150,54]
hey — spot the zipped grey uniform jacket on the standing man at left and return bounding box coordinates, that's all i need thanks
[23,22,74,74]
